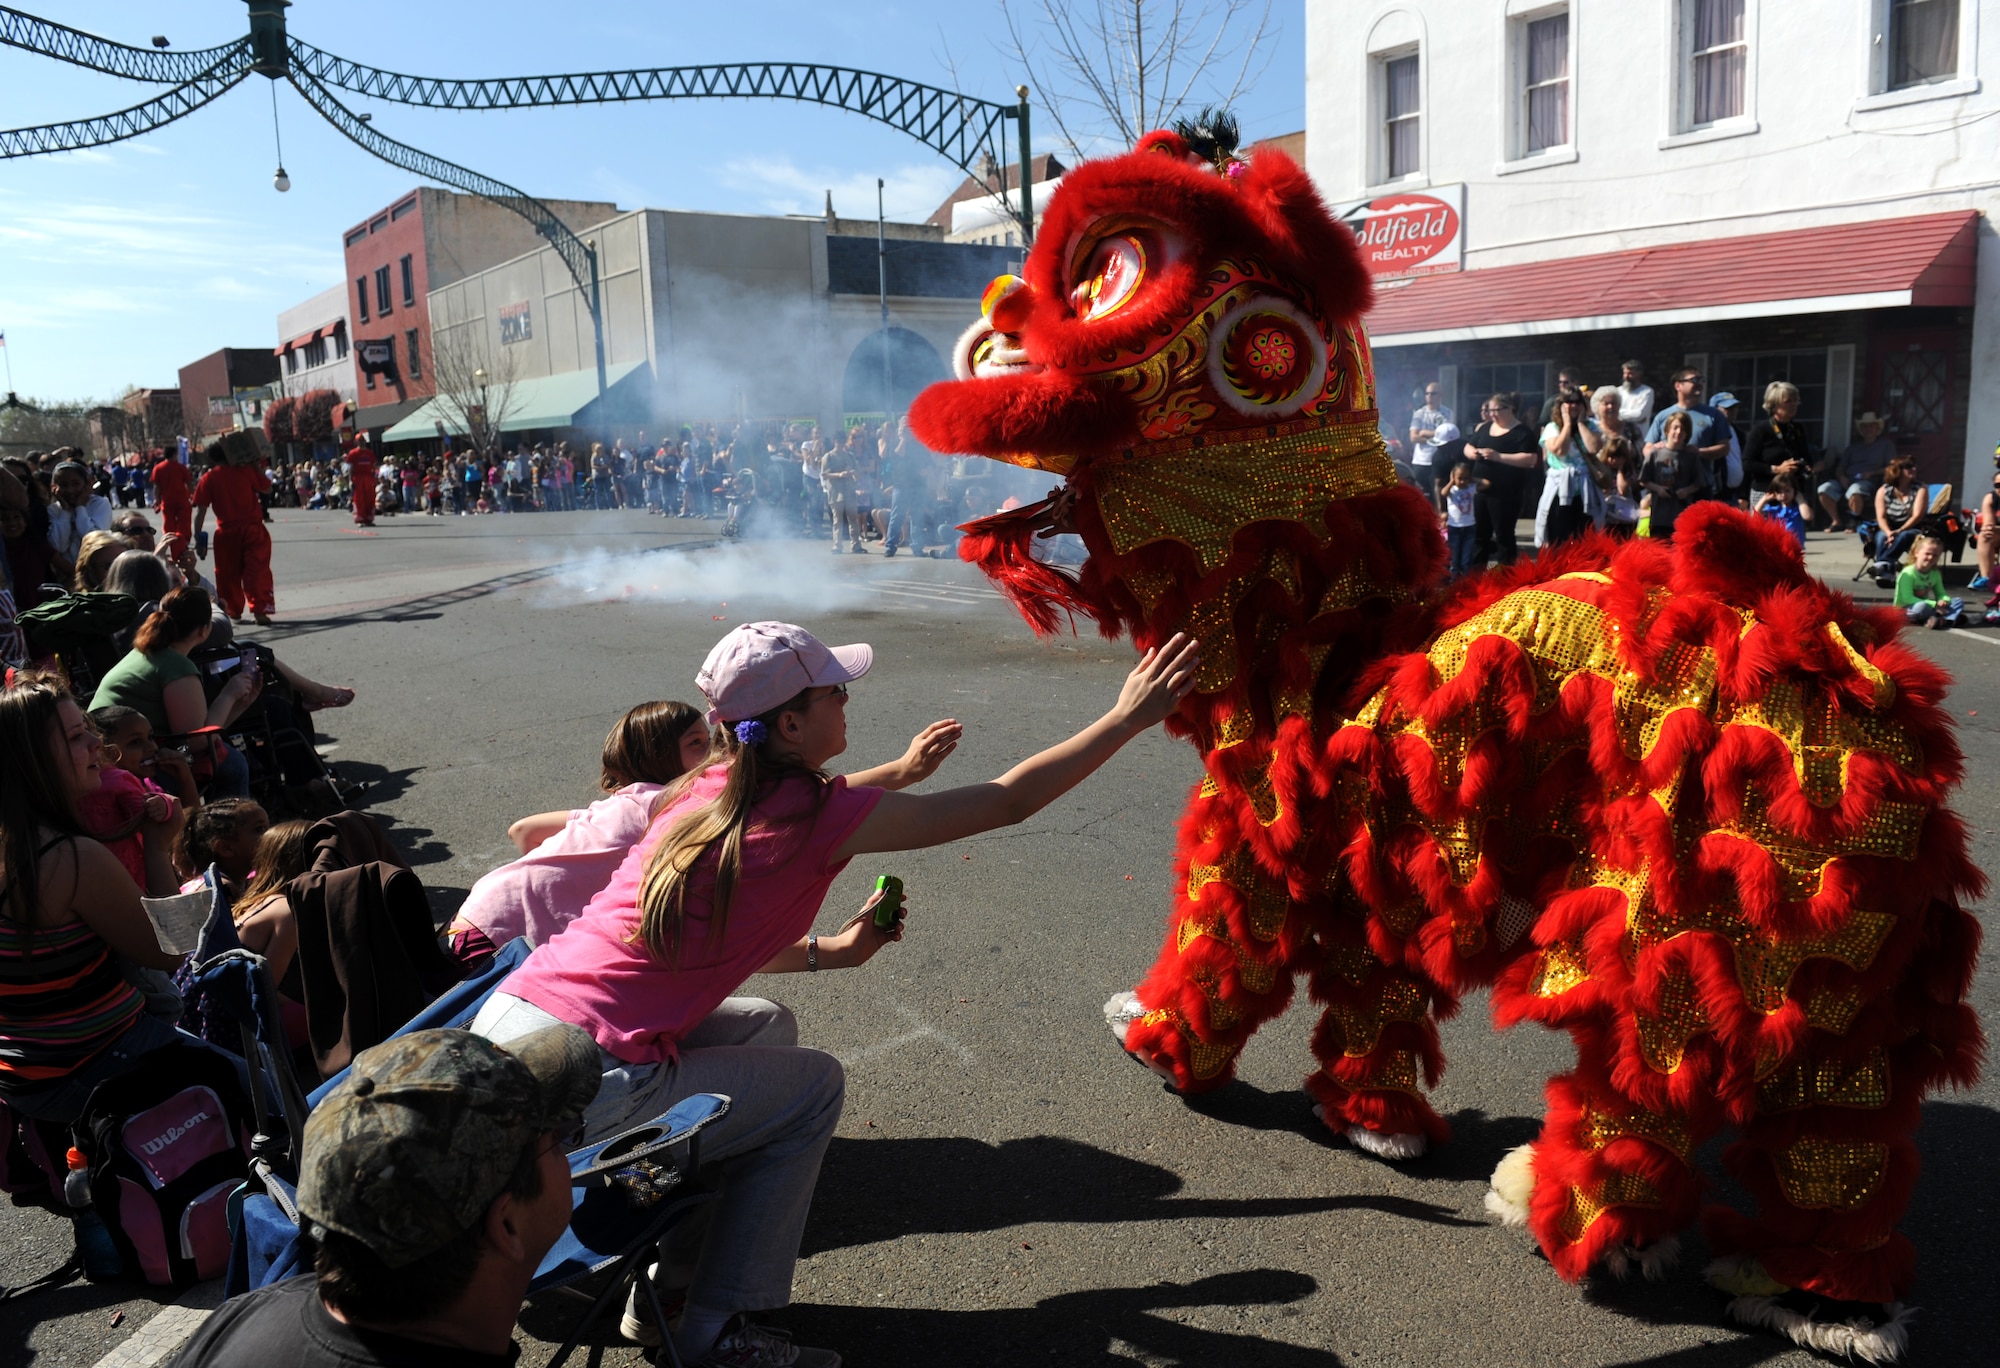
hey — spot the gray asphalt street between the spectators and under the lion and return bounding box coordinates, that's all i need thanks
[0,510,2000,1368]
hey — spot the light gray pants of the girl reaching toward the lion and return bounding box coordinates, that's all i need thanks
[472,992,846,1312]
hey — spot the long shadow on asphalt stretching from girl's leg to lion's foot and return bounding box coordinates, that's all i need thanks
[802,1136,1486,1254]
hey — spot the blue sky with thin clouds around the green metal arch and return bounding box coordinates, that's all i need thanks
[0,0,1306,398]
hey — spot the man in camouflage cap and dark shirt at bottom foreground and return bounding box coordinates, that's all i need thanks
[174,1026,598,1368]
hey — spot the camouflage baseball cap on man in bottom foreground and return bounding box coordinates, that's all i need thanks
[298,1024,602,1268]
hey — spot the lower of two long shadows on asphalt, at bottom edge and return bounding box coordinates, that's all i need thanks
[520,1268,1340,1368]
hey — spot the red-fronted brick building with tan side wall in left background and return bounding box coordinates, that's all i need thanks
[342,186,618,430]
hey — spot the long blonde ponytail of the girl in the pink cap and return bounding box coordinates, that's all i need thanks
[632,690,828,968]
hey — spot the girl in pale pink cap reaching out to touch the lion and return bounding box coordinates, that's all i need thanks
[472,622,1198,1368]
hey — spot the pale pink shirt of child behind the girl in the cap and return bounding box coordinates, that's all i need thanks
[458,784,660,946]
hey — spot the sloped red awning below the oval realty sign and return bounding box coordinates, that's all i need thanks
[1366,210,1978,348]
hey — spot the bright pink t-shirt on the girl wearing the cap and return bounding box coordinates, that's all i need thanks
[500,766,882,1064]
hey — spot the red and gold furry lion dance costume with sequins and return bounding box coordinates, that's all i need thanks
[910,117,1984,1360]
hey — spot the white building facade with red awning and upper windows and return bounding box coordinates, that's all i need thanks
[1306,0,2000,492]
